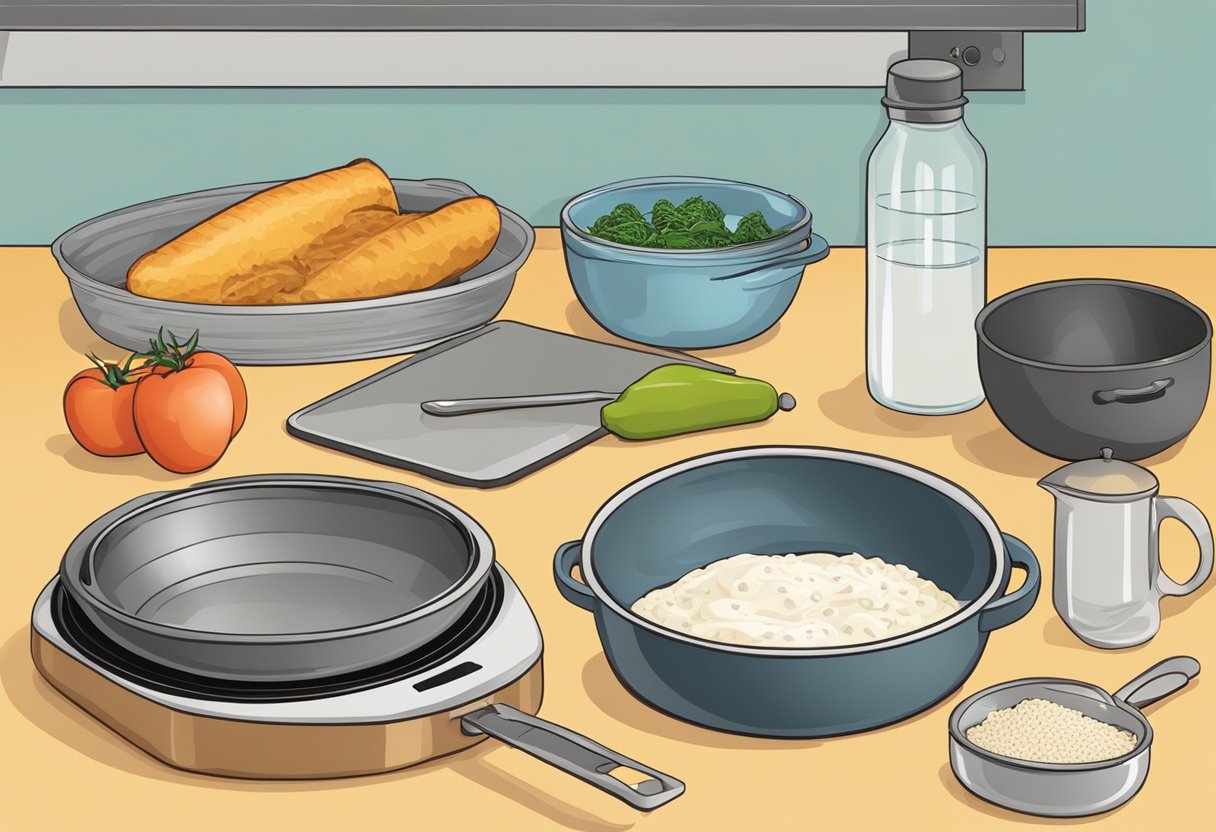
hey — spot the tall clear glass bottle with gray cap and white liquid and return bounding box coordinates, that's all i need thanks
[866,60,987,415]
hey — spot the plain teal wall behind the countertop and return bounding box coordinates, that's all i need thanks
[0,0,1216,246]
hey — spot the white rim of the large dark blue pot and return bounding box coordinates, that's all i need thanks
[581,445,1009,658]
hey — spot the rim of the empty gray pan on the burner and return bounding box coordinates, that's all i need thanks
[65,477,495,645]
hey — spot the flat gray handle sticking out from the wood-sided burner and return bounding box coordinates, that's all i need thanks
[460,704,685,811]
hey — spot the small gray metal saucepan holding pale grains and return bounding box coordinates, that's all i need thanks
[950,656,1199,817]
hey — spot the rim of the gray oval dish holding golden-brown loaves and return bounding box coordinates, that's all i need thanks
[51,179,536,315]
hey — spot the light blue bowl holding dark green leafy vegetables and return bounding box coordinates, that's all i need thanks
[562,176,828,349]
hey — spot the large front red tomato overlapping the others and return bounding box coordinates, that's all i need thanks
[133,366,235,473]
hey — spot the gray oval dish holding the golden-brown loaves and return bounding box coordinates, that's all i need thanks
[51,179,536,364]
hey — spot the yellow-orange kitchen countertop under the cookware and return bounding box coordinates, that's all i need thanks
[0,235,1216,832]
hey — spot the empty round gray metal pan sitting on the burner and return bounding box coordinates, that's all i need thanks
[61,476,494,681]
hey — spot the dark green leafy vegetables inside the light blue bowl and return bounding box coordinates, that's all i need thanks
[587,196,784,248]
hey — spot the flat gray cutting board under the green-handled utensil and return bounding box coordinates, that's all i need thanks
[287,321,733,488]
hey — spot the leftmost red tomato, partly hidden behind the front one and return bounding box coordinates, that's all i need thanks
[63,367,143,456]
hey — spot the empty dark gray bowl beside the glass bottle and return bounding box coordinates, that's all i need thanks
[975,279,1212,460]
